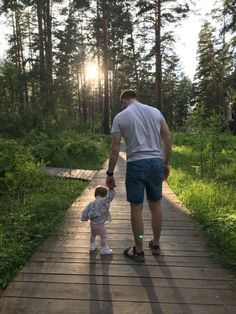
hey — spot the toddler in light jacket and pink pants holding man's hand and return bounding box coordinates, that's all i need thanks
[81,186,115,255]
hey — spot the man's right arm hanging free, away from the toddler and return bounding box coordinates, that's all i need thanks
[161,120,172,180]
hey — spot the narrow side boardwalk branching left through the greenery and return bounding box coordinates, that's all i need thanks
[44,167,97,181]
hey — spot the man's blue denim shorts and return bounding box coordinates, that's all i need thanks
[125,158,163,204]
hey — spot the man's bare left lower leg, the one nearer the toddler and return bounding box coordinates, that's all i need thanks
[130,204,143,253]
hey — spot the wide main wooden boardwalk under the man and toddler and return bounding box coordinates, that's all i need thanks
[0,154,236,314]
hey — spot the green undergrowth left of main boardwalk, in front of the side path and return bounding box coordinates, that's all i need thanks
[0,138,89,290]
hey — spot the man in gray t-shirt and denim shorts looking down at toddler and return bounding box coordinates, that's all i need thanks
[107,90,171,262]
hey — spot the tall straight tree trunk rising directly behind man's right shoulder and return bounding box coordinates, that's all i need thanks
[155,0,163,110]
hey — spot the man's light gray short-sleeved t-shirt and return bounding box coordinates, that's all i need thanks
[111,102,164,162]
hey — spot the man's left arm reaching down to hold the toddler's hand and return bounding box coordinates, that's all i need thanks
[107,132,121,189]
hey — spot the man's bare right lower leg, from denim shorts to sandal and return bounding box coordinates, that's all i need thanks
[148,201,163,245]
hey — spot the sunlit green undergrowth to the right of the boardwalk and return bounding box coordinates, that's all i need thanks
[168,133,236,270]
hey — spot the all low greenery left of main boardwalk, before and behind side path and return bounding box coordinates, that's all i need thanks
[0,135,110,290]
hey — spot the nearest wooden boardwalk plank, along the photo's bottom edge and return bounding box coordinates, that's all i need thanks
[0,297,236,314]
